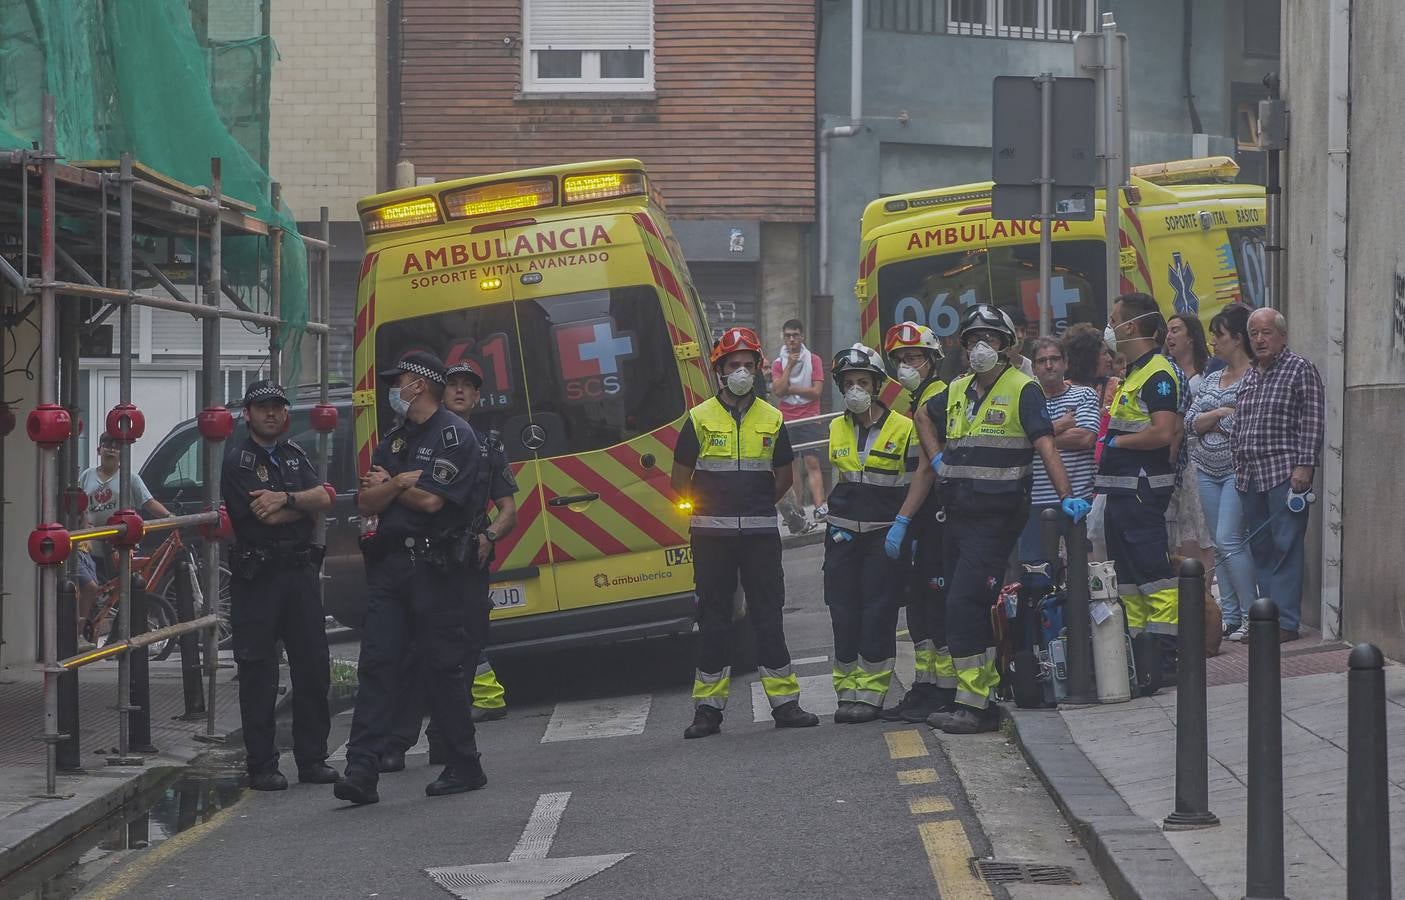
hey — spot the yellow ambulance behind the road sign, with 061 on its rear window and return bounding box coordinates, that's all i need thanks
[854,157,1266,402]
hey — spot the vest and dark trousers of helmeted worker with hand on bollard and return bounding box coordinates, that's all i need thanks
[926,365,1054,716]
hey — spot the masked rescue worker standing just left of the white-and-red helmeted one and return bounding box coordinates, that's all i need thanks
[825,344,932,723]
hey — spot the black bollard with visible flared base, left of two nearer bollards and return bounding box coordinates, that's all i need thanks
[1165,559,1220,830]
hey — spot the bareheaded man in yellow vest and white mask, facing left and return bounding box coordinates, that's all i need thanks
[1093,293,1180,694]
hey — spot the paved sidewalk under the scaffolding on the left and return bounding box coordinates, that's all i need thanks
[0,653,252,880]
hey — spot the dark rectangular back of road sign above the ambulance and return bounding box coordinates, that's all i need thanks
[991,74,1097,222]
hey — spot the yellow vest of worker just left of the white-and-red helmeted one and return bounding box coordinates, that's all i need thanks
[826,410,917,532]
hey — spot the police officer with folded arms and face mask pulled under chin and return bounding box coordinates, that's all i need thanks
[334,351,489,805]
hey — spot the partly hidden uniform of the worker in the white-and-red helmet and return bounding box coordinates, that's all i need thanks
[884,375,957,722]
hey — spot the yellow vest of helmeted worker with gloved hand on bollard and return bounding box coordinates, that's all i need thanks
[937,366,1034,494]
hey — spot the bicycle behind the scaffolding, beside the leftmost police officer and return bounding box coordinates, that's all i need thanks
[83,529,233,660]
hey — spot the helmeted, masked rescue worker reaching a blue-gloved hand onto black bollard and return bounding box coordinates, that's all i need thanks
[917,303,1089,734]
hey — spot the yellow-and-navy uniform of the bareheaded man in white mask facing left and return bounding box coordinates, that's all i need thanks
[1094,343,1180,668]
